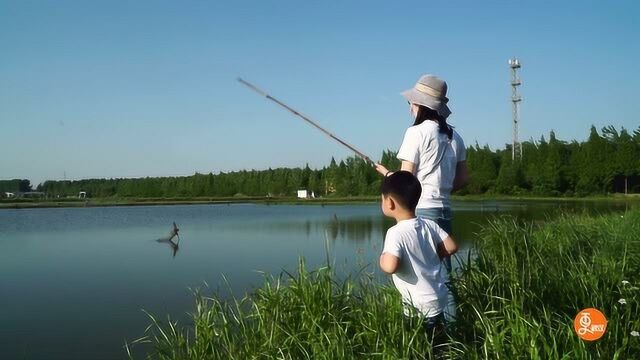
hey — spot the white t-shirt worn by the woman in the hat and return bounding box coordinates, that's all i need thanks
[397,120,466,209]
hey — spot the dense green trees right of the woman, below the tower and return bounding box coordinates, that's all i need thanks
[465,126,640,196]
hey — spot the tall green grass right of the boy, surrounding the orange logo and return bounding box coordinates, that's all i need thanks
[457,210,640,359]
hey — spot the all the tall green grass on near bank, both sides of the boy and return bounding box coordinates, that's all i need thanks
[133,210,640,359]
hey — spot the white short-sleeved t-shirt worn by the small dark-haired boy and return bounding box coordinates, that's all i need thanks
[382,217,449,317]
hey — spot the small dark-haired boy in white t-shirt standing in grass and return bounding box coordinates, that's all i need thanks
[380,171,458,330]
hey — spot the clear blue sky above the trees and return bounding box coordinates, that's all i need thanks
[0,0,640,184]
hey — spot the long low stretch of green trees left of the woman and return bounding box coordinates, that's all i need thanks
[38,152,399,198]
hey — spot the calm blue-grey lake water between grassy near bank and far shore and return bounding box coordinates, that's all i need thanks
[0,201,638,360]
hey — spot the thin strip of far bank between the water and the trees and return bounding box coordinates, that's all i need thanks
[0,194,640,209]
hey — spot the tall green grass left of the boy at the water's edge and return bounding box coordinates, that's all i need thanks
[128,262,448,359]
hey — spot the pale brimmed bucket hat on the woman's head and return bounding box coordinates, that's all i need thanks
[401,74,451,119]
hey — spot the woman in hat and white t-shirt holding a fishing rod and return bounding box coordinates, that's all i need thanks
[376,75,468,272]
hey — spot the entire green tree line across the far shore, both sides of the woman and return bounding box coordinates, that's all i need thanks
[0,126,640,198]
